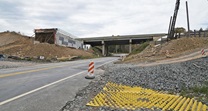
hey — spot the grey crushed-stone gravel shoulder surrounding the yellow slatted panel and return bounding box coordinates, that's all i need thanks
[61,58,208,111]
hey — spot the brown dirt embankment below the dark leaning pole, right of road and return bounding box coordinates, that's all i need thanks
[124,37,208,63]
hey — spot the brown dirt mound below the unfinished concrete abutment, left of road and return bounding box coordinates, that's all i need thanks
[0,32,93,58]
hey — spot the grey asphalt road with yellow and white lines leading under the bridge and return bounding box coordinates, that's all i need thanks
[0,57,118,111]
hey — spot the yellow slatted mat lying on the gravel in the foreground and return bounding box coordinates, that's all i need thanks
[87,82,207,111]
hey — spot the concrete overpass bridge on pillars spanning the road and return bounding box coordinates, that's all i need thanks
[76,33,167,55]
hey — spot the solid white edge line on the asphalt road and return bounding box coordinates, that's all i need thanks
[0,71,85,106]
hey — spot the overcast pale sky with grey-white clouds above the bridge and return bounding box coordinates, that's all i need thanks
[0,0,208,37]
